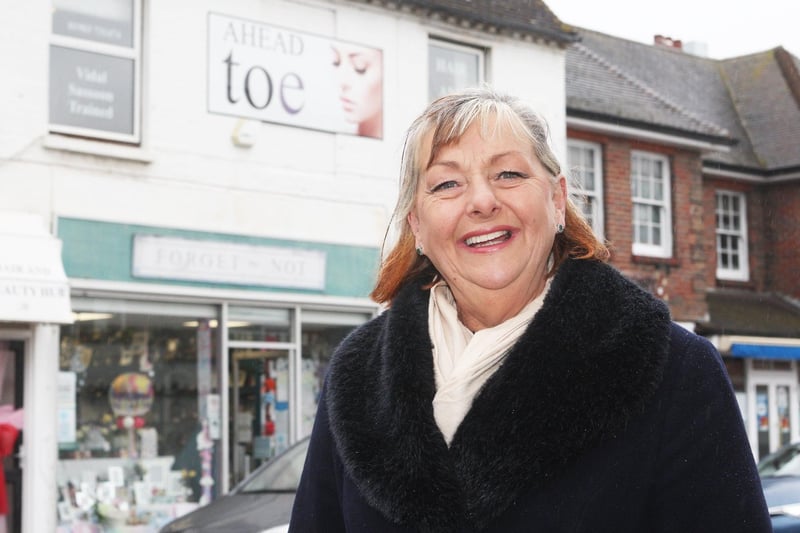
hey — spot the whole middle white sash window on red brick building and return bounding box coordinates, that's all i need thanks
[631,152,672,257]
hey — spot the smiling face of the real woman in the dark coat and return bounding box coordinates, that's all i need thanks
[408,119,566,314]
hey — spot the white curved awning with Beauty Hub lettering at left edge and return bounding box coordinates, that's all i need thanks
[0,235,72,324]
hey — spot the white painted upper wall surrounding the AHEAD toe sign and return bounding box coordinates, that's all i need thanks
[0,0,565,246]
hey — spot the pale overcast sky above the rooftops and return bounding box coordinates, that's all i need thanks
[544,0,800,59]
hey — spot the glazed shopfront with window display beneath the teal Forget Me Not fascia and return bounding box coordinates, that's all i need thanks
[57,298,372,533]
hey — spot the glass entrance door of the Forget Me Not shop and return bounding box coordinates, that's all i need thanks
[230,347,294,486]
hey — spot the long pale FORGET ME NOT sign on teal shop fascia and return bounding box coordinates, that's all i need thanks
[132,235,326,290]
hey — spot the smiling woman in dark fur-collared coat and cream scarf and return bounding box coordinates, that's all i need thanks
[290,87,770,533]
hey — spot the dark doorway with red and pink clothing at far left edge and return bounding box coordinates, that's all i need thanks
[0,340,25,533]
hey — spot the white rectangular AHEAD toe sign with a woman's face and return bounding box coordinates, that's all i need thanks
[208,13,383,137]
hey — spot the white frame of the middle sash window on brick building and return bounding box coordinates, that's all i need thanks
[630,150,672,258]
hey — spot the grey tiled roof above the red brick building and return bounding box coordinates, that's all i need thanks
[566,28,800,171]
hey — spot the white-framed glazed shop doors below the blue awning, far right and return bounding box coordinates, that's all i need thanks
[748,360,800,459]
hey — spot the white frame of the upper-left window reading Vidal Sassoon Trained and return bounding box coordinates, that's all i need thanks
[48,0,143,144]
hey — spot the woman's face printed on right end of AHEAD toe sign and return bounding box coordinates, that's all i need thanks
[331,42,383,138]
